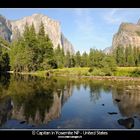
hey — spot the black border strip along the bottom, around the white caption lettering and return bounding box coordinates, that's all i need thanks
[0,130,140,140]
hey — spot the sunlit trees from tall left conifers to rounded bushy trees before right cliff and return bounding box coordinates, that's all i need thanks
[9,23,115,72]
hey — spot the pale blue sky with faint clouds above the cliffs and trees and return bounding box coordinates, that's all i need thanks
[0,8,140,52]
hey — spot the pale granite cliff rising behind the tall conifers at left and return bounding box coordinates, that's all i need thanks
[0,14,74,54]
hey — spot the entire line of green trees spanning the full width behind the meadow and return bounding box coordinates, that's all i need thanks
[0,23,140,72]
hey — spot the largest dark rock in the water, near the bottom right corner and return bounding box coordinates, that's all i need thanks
[118,118,134,129]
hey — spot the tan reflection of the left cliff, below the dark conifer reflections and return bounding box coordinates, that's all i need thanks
[12,93,62,125]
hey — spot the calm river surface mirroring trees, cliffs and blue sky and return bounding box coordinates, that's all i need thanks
[0,75,140,129]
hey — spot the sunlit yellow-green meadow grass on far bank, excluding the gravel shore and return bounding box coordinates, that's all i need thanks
[17,67,140,77]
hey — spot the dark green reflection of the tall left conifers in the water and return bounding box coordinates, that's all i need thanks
[8,77,53,122]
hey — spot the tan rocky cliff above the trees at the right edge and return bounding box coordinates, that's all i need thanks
[112,21,140,49]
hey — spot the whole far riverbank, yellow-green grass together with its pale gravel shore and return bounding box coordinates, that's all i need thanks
[9,67,140,81]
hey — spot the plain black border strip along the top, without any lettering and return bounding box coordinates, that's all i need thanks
[0,0,140,8]
